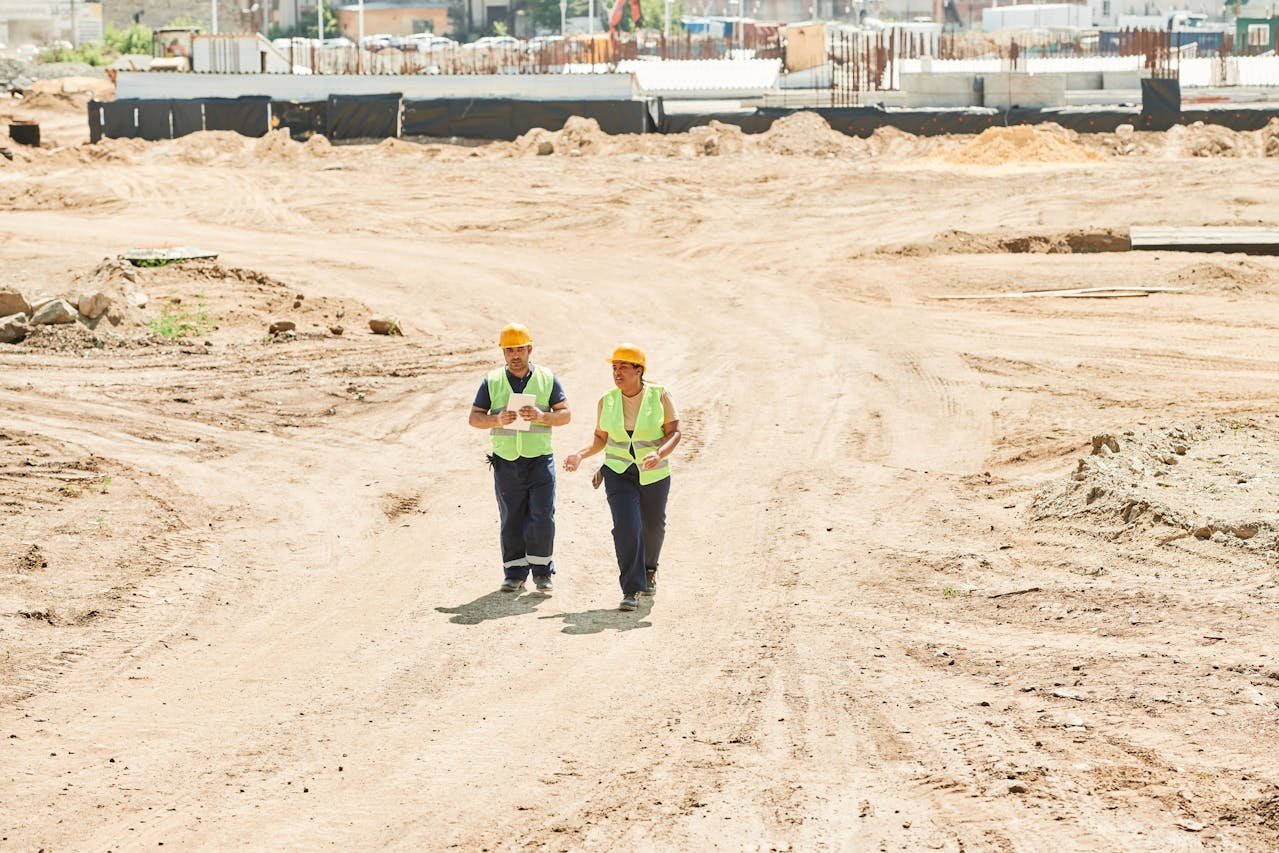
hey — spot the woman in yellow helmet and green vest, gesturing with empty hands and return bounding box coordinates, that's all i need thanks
[564,344,679,610]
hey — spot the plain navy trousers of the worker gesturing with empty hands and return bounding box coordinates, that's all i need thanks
[604,466,670,595]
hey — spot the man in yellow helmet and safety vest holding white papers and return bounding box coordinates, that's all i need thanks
[471,324,572,593]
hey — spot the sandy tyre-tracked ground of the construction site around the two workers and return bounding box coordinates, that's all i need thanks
[0,101,1279,850]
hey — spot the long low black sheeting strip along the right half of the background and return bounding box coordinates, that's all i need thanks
[661,106,1279,138]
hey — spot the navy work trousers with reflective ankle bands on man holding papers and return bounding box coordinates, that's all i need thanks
[492,455,555,581]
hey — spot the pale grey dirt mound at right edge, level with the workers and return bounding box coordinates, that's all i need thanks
[1028,416,1279,550]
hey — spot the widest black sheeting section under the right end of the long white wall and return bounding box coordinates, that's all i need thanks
[403,98,657,141]
